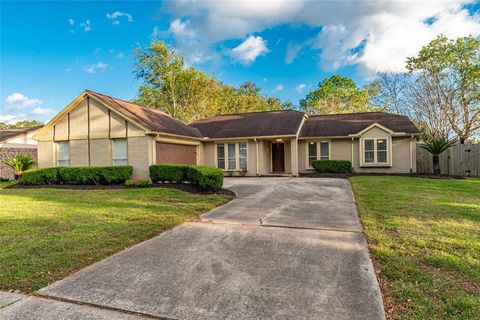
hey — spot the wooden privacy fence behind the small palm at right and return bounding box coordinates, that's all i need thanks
[417,144,480,176]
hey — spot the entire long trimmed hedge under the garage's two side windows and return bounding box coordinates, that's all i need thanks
[23,166,133,185]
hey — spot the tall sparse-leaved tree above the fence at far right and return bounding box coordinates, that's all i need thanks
[407,35,480,143]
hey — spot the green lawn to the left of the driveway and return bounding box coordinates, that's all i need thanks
[0,183,228,292]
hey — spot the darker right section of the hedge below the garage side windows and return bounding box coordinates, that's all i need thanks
[59,166,133,185]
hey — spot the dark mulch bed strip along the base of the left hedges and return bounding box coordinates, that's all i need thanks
[5,183,235,198]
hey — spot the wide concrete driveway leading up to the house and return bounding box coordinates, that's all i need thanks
[0,178,385,319]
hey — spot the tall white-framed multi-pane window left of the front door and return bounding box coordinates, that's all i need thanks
[216,142,248,170]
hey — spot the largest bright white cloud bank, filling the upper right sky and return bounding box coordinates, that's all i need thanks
[162,0,480,73]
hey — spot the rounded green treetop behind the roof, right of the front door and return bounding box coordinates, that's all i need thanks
[300,75,375,114]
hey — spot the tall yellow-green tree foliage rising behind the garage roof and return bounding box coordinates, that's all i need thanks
[134,41,286,122]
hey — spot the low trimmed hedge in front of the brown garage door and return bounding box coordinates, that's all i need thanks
[150,164,223,192]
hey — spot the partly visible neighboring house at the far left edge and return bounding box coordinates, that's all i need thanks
[0,126,42,179]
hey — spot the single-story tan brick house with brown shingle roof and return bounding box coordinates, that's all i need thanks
[36,90,419,179]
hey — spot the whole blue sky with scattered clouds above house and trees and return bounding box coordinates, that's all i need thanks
[0,0,480,122]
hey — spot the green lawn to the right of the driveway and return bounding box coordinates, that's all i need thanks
[350,176,480,319]
